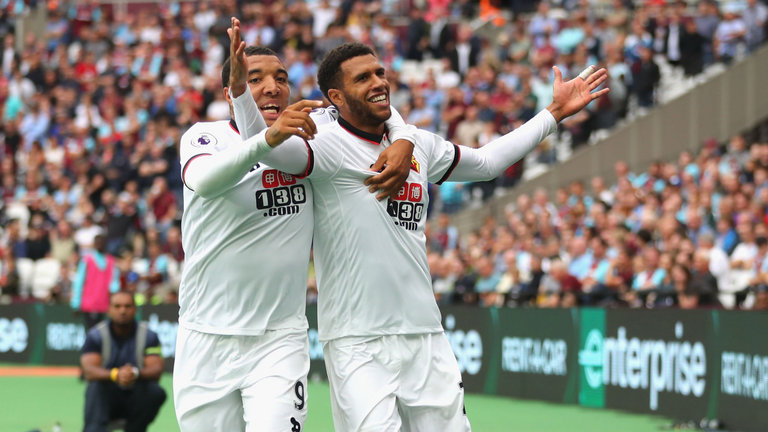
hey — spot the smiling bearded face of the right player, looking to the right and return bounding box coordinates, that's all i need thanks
[339,54,391,132]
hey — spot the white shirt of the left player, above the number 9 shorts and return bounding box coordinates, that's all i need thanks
[179,121,313,335]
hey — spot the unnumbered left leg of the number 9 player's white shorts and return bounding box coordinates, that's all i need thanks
[173,327,245,432]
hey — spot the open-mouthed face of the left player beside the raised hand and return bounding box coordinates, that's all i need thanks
[248,55,290,126]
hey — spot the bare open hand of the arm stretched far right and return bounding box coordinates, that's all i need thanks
[547,66,610,122]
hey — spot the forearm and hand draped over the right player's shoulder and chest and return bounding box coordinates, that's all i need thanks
[365,107,415,201]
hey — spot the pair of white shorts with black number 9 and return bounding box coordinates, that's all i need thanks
[173,325,309,432]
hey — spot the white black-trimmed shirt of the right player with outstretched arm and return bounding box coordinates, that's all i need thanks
[309,119,459,340]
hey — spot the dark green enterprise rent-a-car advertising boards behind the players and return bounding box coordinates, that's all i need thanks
[0,304,768,431]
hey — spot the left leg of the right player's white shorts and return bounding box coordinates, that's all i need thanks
[323,338,401,432]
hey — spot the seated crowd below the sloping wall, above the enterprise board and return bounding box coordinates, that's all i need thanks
[427,124,768,310]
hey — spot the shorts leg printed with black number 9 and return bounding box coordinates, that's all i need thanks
[240,331,309,432]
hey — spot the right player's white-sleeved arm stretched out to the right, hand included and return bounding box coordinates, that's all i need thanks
[448,67,609,181]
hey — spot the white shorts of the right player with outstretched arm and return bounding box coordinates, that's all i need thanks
[323,333,471,432]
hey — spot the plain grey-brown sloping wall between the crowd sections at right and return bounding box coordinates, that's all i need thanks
[453,45,768,232]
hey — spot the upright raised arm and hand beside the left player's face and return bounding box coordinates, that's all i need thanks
[227,17,267,140]
